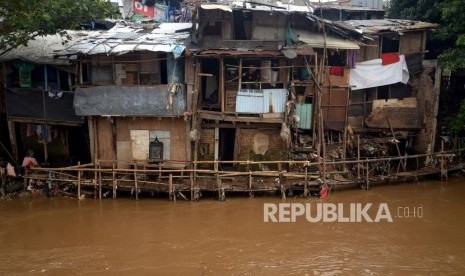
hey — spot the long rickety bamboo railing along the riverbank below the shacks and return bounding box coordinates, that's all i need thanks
[25,149,462,200]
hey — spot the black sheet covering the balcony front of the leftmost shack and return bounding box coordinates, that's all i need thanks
[6,89,84,124]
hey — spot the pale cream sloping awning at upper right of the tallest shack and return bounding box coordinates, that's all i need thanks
[295,30,360,49]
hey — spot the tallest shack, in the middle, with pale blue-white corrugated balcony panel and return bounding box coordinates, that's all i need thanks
[186,2,360,177]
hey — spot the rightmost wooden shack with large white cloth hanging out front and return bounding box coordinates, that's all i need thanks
[324,19,439,160]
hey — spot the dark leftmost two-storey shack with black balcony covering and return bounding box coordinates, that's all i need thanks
[0,31,89,165]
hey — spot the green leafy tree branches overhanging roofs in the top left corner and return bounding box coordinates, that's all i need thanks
[0,0,117,55]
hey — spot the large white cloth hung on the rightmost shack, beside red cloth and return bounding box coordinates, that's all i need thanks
[349,55,410,90]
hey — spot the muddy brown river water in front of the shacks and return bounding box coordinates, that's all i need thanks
[0,178,465,275]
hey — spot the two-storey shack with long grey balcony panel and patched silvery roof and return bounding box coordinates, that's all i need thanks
[54,23,191,171]
